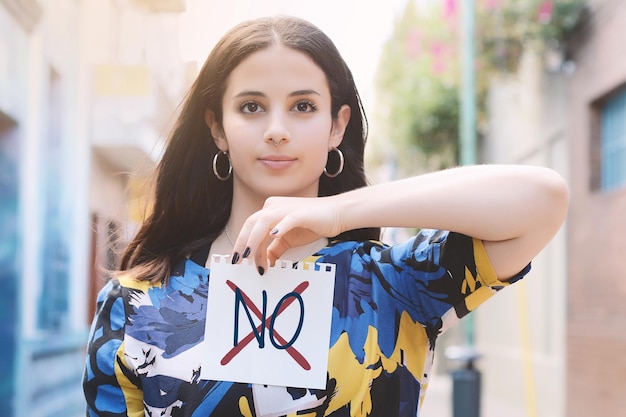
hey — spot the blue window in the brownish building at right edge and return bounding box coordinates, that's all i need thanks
[600,88,626,190]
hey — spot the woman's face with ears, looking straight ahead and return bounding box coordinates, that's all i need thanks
[206,45,350,200]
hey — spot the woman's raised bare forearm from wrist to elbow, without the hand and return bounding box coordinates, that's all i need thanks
[339,165,567,241]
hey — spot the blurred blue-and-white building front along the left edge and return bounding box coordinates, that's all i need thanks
[0,0,89,416]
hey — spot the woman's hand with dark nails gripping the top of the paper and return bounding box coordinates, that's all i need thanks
[233,196,343,275]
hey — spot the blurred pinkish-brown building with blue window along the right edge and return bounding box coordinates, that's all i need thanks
[565,0,626,417]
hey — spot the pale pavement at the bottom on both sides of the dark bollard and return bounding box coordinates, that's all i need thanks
[420,374,526,417]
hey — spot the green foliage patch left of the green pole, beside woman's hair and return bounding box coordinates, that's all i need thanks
[377,1,459,173]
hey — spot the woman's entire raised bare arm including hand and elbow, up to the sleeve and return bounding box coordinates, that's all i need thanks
[236,165,568,279]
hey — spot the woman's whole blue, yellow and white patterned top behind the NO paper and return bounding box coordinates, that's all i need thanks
[83,230,529,417]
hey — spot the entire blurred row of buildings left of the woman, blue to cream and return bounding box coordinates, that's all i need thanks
[0,0,190,417]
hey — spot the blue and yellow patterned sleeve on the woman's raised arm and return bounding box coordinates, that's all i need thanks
[370,230,530,332]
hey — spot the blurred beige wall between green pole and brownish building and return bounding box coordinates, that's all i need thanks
[475,53,568,417]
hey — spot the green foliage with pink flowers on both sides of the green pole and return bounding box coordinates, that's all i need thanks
[376,0,586,174]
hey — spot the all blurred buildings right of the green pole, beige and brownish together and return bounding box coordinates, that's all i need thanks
[476,0,626,417]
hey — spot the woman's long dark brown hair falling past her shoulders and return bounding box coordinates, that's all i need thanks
[120,17,380,280]
